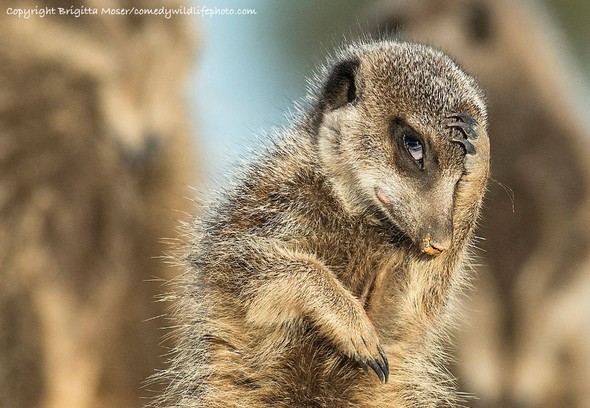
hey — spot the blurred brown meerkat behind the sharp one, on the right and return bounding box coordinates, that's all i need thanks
[376,0,590,408]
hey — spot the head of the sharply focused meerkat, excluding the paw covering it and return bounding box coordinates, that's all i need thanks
[315,42,486,255]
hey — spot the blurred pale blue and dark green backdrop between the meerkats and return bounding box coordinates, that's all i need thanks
[191,0,370,182]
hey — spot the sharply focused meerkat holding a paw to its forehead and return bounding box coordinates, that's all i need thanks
[151,41,489,408]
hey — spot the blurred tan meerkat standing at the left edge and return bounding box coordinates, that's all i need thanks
[0,1,199,408]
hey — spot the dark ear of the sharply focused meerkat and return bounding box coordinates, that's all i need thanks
[322,59,359,111]
